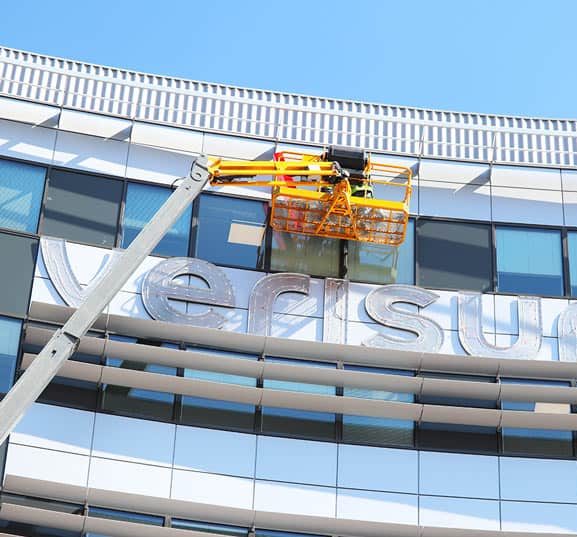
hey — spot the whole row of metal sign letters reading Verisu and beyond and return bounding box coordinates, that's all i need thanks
[40,237,577,362]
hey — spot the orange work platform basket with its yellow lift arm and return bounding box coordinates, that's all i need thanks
[211,152,412,246]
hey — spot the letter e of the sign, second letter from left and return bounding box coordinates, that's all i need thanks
[142,257,236,328]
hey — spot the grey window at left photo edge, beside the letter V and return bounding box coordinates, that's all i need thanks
[0,233,38,317]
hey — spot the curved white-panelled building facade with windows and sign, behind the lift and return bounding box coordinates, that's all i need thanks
[0,48,577,537]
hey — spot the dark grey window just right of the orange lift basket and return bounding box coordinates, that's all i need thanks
[417,220,492,291]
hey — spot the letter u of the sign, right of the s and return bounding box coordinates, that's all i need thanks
[459,293,542,360]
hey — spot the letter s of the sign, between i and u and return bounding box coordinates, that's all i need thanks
[363,285,443,352]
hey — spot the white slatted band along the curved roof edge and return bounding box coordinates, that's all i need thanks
[0,48,577,166]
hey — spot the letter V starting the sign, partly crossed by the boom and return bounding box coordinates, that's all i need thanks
[40,237,122,308]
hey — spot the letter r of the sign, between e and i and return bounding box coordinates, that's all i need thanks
[248,272,311,336]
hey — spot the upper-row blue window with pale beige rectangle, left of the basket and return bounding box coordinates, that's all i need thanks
[194,194,268,268]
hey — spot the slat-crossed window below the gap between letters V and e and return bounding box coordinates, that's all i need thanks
[102,336,176,421]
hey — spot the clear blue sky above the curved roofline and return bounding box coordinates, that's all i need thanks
[0,0,577,118]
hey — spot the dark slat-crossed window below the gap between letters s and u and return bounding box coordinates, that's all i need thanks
[418,373,499,453]
